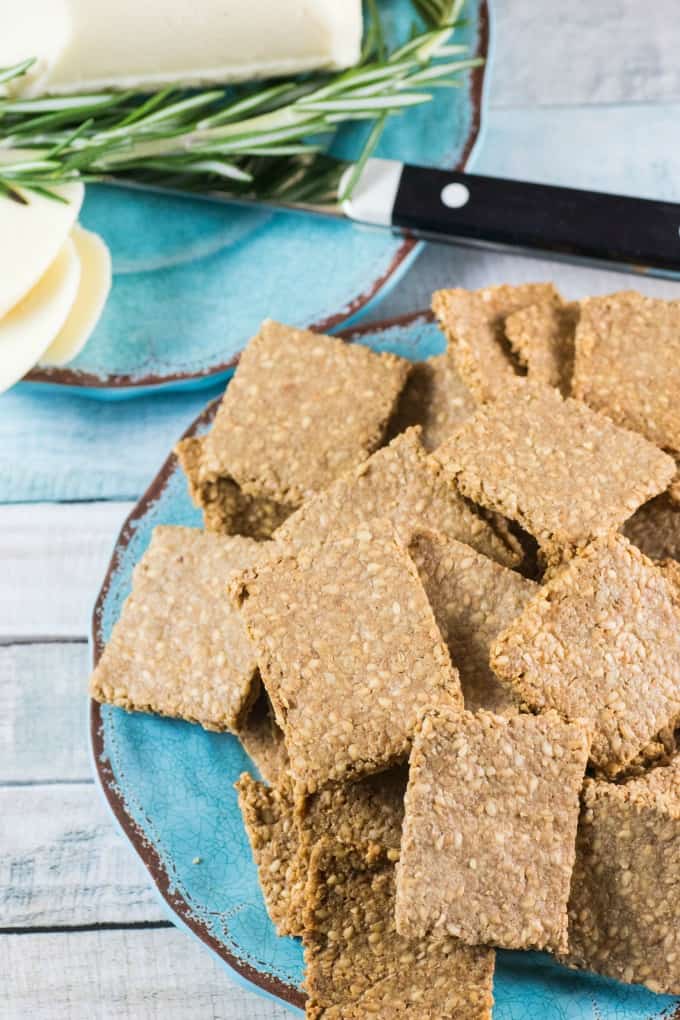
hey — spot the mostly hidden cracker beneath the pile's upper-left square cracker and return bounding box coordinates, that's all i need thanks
[174,437,295,542]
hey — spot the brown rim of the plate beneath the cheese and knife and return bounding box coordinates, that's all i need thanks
[21,0,491,396]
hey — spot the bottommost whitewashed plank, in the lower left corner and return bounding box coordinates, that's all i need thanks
[0,928,291,1020]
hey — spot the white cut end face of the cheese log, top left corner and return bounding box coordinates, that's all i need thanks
[0,0,71,95]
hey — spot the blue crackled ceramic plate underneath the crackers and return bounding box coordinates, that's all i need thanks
[91,312,680,1020]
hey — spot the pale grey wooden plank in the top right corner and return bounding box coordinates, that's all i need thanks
[490,0,680,107]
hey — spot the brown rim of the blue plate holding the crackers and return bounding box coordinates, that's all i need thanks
[89,309,434,1010]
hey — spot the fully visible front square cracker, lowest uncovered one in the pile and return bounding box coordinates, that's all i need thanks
[397,711,588,950]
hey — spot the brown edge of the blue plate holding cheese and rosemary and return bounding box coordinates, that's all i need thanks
[23,0,489,390]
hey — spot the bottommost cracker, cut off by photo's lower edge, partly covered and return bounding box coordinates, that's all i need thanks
[304,840,494,1020]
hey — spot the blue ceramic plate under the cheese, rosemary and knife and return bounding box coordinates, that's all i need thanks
[22,0,488,399]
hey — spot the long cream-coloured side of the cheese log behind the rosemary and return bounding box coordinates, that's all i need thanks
[22,0,362,93]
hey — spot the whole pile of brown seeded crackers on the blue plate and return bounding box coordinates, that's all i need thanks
[92,284,680,1020]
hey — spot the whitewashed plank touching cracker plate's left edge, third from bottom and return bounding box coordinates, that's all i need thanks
[0,644,92,783]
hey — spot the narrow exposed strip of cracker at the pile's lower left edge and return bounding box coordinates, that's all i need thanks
[236,772,307,935]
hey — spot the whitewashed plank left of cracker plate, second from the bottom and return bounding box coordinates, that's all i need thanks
[0,784,166,930]
